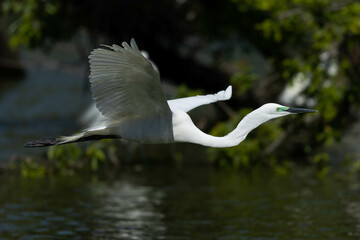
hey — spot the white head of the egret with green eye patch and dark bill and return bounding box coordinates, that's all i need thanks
[258,103,317,119]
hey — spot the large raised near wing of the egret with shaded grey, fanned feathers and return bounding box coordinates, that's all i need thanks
[89,39,173,142]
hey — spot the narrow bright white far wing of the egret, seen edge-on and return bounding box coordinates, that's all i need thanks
[168,86,232,112]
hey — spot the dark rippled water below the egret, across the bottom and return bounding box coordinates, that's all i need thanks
[0,168,360,240]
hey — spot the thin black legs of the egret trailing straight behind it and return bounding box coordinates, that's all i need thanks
[24,132,120,148]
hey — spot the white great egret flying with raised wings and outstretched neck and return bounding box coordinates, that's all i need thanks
[25,39,316,147]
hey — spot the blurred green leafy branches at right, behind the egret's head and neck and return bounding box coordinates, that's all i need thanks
[209,0,360,169]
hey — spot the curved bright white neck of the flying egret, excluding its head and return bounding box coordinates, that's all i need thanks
[173,110,266,148]
